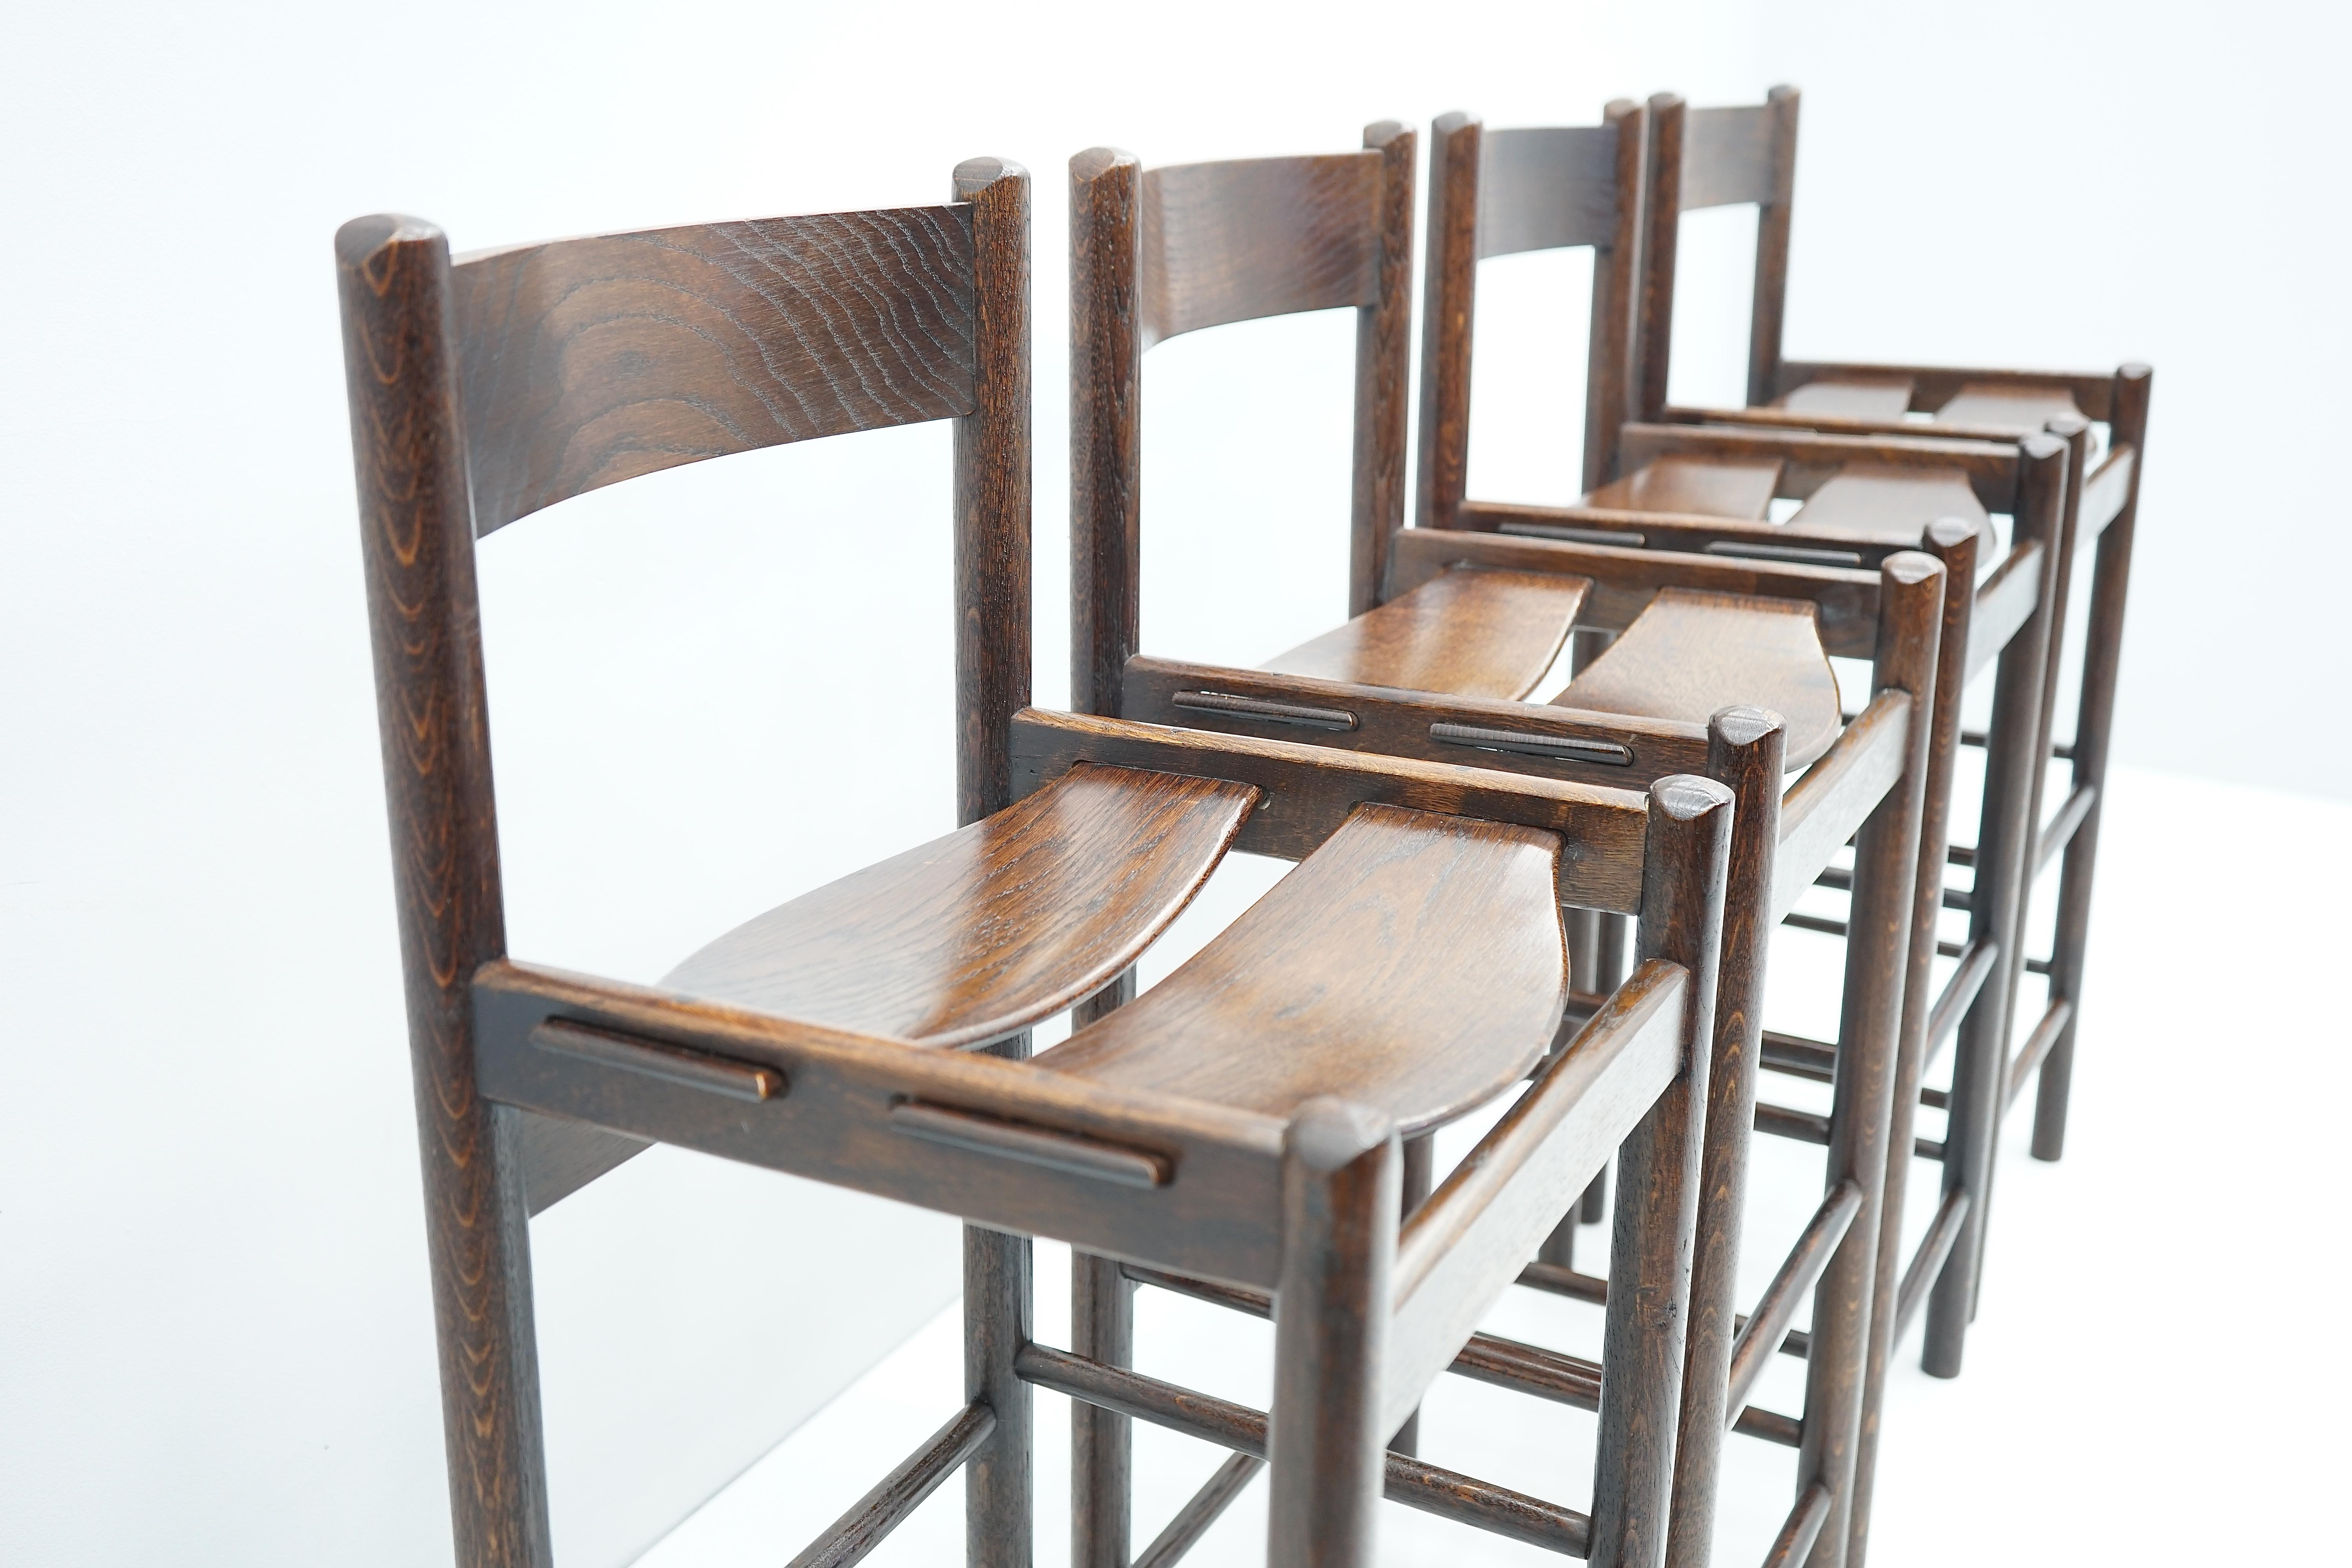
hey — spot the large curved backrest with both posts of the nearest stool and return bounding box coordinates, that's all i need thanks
[336,158,1030,853]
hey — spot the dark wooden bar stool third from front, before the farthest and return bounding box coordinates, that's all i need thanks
[1418,103,2112,1542]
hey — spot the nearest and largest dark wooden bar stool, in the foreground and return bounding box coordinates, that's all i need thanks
[336,160,1731,1568]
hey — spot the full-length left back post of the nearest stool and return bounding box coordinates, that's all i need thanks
[334,216,553,1568]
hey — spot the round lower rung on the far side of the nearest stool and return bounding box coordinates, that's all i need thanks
[1014,1345,1592,1556]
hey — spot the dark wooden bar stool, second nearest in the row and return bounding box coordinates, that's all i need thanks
[1070,125,1947,1568]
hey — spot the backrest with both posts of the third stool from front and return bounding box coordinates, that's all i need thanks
[1414,101,1646,529]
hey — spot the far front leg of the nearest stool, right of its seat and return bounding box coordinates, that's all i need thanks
[1588,773,1733,1568]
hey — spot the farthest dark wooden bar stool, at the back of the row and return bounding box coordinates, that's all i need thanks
[1637,87,2154,1377]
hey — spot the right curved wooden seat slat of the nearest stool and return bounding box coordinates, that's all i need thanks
[1035,806,1569,1133]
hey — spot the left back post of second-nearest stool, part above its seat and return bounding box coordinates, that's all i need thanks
[1070,148,1143,717]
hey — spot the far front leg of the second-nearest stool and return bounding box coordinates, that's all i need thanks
[1797,550,1945,1568]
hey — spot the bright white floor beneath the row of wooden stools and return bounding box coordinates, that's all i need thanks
[640,773,2352,1568]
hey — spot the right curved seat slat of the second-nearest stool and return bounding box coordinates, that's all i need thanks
[1552,588,1844,769]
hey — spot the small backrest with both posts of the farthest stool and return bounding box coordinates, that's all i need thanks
[1635,87,1799,418]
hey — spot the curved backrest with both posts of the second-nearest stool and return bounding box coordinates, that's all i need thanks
[1070,120,1414,715]
